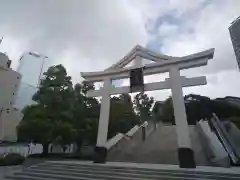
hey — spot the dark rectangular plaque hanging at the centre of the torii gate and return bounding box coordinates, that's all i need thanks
[130,68,144,92]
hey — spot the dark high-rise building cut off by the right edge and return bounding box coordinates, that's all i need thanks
[229,16,240,69]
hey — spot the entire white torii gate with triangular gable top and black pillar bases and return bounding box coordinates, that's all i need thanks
[81,45,214,168]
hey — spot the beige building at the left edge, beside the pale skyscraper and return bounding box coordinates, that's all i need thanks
[0,53,22,141]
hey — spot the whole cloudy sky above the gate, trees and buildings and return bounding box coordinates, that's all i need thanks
[0,0,240,100]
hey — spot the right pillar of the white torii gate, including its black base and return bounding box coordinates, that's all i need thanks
[169,67,196,168]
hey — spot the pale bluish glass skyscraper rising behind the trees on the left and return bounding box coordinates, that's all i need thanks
[15,52,47,110]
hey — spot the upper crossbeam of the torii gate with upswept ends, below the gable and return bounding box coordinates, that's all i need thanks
[81,49,214,82]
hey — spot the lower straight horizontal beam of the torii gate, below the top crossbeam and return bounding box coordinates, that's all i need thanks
[87,76,207,97]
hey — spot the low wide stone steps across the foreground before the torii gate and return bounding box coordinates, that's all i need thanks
[6,161,240,180]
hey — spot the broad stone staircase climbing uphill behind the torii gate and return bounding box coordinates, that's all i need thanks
[107,125,209,166]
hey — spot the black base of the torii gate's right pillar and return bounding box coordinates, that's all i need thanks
[178,148,196,168]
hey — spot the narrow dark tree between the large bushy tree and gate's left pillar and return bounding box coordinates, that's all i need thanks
[72,81,100,148]
